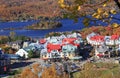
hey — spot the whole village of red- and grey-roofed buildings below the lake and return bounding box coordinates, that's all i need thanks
[2,33,120,59]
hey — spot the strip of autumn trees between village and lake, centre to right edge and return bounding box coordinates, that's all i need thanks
[46,25,120,39]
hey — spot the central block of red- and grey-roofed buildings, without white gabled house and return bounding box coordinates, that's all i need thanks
[40,33,83,59]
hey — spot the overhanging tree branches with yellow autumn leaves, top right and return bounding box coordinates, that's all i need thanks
[58,0,120,26]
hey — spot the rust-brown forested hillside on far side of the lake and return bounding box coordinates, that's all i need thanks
[0,0,116,21]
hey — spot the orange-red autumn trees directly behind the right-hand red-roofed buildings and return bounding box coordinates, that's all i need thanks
[80,26,120,39]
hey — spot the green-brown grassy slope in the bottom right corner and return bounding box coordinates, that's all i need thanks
[73,62,120,78]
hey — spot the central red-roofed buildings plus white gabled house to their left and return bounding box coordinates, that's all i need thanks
[16,33,83,59]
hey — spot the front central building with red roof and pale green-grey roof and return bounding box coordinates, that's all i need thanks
[41,44,77,59]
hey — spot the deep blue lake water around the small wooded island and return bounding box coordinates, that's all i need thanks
[0,14,120,37]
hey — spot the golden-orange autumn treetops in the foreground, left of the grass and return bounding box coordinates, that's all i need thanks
[14,63,68,78]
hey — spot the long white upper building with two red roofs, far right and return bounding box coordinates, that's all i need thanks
[86,33,120,45]
